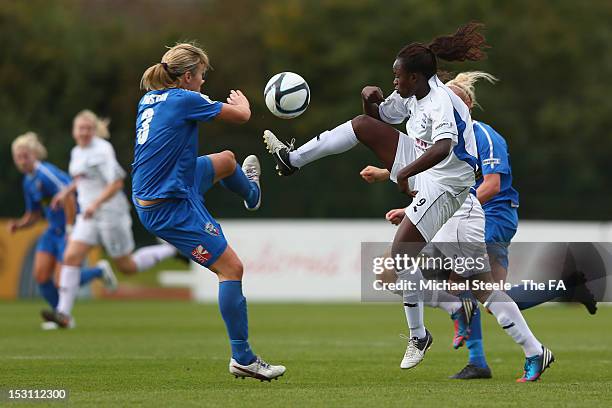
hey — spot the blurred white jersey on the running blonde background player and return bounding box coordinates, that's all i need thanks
[69,137,130,218]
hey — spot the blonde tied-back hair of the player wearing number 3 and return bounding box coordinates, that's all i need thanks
[140,43,211,91]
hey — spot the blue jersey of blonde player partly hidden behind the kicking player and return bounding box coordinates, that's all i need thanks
[474,121,519,213]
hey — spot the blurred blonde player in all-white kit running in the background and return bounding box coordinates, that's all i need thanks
[43,110,176,328]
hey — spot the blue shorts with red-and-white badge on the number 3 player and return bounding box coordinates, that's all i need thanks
[134,156,227,266]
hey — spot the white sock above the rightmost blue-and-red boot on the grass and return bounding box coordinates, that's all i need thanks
[484,290,542,357]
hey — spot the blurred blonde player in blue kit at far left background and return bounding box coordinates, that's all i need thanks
[8,132,114,329]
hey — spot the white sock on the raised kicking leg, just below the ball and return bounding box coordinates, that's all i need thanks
[289,121,359,168]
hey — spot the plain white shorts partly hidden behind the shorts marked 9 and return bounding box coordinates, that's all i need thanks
[432,194,491,278]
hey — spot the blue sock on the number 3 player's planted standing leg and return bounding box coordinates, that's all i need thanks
[219,280,256,365]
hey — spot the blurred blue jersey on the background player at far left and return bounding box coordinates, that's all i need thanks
[23,162,70,231]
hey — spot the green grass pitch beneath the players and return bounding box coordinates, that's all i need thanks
[0,301,612,407]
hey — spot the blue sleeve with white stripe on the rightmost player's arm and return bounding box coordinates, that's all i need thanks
[474,123,510,174]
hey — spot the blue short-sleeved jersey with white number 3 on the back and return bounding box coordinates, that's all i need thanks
[132,88,223,200]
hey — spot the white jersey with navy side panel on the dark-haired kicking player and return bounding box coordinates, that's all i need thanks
[378,75,478,187]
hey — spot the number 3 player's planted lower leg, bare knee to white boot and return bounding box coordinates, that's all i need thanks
[210,246,285,381]
